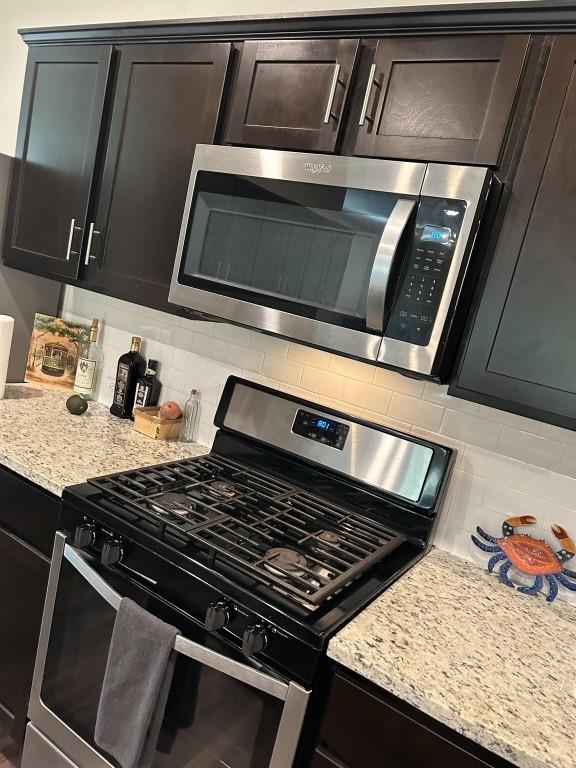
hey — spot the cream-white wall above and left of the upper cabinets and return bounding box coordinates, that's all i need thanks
[0,0,540,155]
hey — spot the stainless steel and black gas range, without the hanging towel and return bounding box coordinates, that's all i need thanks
[22,377,453,768]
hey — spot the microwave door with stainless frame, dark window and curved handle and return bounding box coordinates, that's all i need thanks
[170,145,426,360]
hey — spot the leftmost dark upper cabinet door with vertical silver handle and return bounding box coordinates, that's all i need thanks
[4,45,112,277]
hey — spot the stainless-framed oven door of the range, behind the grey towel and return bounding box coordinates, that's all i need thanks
[28,533,309,768]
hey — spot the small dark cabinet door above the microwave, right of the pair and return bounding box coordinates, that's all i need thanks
[355,35,529,165]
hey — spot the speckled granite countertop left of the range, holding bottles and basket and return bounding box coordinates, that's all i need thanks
[0,384,208,496]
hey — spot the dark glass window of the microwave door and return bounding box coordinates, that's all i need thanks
[179,171,398,318]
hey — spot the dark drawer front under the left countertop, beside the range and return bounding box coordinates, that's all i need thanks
[0,467,60,557]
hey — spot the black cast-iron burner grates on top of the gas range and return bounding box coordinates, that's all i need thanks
[89,454,406,609]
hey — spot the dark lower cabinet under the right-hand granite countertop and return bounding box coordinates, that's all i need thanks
[309,668,512,768]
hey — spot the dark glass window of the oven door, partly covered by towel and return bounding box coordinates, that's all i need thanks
[42,559,282,768]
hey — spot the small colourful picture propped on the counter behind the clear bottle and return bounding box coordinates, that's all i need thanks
[25,314,90,389]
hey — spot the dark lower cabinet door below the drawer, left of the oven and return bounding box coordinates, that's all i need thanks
[0,528,50,740]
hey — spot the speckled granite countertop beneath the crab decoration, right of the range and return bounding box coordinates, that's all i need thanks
[328,549,576,768]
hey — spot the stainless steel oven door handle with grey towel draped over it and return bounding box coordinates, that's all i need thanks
[64,544,300,701]
